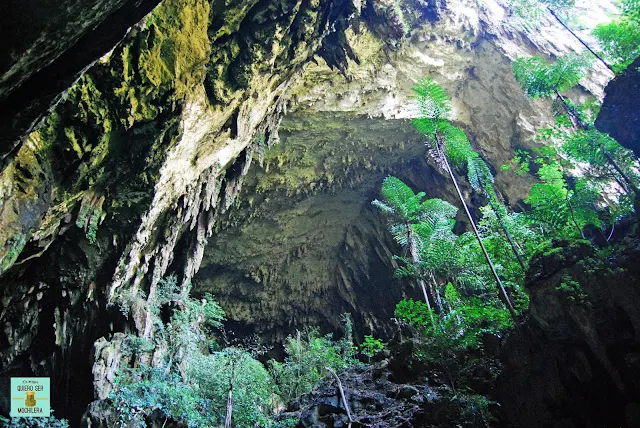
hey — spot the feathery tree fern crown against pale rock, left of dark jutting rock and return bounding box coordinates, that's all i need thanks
[513,53,590,98]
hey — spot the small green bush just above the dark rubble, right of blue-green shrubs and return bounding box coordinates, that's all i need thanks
[269,329,355,402]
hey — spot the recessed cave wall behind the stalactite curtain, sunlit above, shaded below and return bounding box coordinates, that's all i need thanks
[194,1,605,340]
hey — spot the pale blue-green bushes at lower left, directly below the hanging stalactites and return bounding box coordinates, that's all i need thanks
[109,276,264,427]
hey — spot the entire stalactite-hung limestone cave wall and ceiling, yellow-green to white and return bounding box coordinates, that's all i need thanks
[0,0,616,420]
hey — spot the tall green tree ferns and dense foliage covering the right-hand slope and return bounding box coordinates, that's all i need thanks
[373,62,640,426]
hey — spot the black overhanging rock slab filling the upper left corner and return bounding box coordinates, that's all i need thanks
[0,0,160,159]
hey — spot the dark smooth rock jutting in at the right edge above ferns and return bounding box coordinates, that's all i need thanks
[596,58,640,156]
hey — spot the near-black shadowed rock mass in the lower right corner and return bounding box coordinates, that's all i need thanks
[497,241,640,428]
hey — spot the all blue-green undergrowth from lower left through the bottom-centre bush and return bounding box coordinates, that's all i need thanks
[108,276,358,427]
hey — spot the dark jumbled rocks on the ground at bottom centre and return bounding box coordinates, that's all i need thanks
[280,348,500,428]
